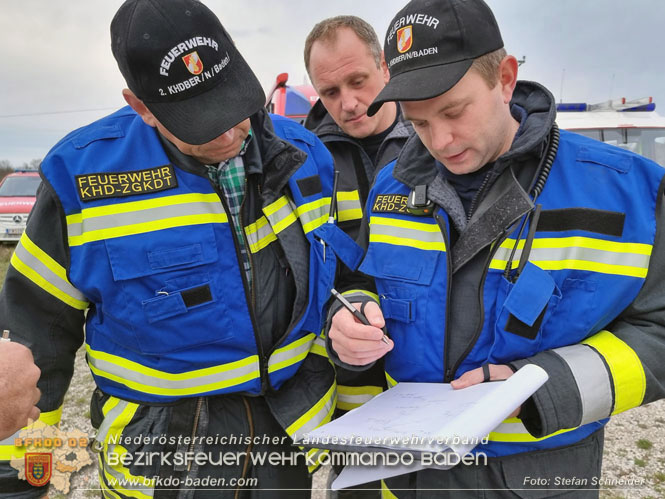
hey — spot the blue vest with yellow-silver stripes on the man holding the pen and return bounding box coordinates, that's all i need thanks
[360,131,665,456]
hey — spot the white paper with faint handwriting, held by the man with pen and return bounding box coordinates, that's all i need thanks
[299,365,547,454]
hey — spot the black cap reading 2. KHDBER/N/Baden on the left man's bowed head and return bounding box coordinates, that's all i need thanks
[111,0,265,145]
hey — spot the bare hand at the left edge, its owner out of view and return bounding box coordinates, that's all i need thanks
[0,341,41,440]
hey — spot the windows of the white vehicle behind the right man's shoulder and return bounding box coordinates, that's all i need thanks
[575,128,665,166]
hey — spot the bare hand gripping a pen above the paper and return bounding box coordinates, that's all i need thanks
[328,302,395,366]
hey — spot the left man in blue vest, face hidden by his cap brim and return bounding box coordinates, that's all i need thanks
[0,0,361,498]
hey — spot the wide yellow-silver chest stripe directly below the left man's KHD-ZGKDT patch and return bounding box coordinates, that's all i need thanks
[67,193,228,246]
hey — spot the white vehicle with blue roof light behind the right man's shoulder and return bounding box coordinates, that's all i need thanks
[556,97,665,167]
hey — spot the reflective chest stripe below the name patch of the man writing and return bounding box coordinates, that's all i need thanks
[369,217,446,251]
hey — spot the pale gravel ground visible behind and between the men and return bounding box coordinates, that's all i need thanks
[57,350,665,499]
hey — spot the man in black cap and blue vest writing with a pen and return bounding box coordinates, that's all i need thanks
[328,0,665,498]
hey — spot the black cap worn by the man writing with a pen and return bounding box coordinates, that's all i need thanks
[367,0,503,116]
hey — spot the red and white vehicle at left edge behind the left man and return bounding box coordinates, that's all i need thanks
[0,170,41,242]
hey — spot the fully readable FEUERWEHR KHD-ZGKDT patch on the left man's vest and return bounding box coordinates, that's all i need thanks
[76,165,178,201]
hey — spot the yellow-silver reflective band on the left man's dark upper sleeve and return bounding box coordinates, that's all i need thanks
[10,232,88,310]
